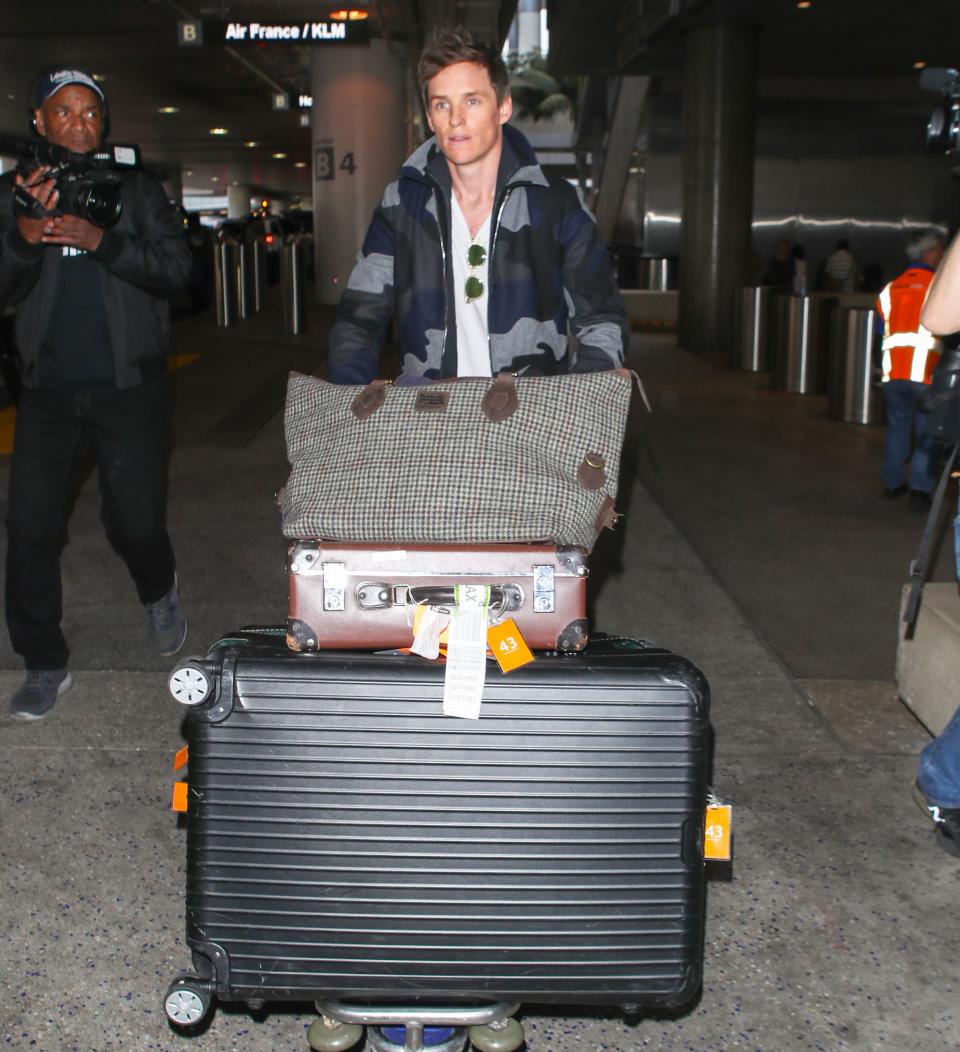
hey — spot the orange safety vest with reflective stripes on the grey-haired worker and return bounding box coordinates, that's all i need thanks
[877,266,943,384]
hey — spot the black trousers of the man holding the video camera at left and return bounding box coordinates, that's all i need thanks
[6,381,173,669]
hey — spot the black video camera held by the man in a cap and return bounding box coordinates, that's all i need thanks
[0,136,140,226]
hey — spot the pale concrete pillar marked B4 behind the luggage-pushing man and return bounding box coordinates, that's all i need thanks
[312,40,405,304]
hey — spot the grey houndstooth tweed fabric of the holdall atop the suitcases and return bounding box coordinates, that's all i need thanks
[283,370,632,551]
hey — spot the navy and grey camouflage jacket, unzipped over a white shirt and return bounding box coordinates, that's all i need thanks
[328,125,629,384]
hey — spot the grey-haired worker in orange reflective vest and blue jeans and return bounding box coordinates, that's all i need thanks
[877,230,943,511]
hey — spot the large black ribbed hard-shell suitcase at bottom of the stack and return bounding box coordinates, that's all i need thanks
[170,629,709,1011]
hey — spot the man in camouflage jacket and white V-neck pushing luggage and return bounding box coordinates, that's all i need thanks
[328,28,629,384]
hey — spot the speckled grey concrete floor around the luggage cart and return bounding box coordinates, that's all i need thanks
[0,298,960,1052]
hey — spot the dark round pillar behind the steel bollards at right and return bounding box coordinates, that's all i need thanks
[677,24,756,355]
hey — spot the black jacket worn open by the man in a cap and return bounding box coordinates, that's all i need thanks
[0,171,190,388]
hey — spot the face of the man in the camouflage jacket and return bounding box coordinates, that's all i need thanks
[427,62,513,172]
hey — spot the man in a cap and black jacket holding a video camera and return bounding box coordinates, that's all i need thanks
[0,69,190,720]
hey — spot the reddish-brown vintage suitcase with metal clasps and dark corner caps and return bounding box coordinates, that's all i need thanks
[287,541,589,651]
